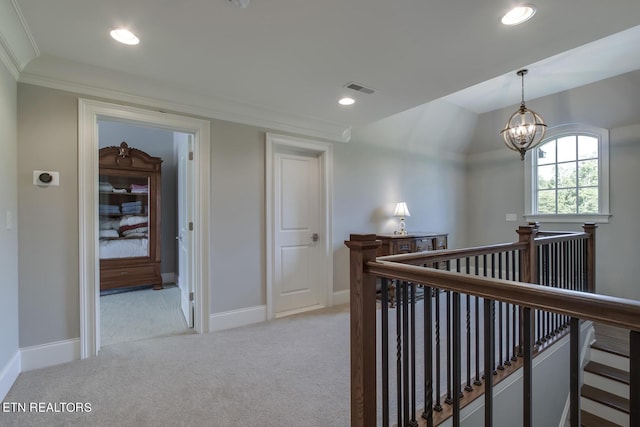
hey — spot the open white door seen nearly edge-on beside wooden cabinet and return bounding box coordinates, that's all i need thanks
[175,134,194,328]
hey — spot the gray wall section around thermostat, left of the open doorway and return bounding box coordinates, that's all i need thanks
[18,84,80,347]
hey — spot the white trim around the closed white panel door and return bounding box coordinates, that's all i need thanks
[265,133,333,320]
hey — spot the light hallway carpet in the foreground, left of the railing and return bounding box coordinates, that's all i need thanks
[0,306,349,427]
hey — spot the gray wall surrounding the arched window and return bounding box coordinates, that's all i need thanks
[467,71,640,300]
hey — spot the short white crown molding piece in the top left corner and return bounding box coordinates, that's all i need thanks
[0,0,40,80]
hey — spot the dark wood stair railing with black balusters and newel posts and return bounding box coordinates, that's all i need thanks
[345,223,640,427]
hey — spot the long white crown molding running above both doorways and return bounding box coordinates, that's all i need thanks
[19,67,351,142]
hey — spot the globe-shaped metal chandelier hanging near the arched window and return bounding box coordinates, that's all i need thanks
[500,70,547,160]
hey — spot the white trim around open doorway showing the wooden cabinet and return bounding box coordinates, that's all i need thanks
[78,98,211,359]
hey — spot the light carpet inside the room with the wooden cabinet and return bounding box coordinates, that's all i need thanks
[100,284,191,346]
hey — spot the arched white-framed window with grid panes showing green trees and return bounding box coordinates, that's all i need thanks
[525,125,610,223]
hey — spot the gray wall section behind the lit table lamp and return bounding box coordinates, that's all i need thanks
[333,141,466,291]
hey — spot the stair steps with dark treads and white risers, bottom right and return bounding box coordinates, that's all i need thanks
[580,324,629,427]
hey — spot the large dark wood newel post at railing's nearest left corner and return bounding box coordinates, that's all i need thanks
[345,234,381,427]
